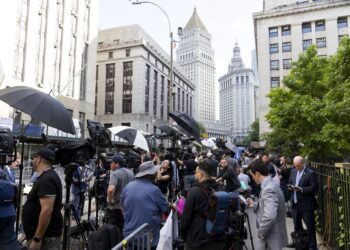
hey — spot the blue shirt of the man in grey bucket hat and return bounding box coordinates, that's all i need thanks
[120,179,168,247]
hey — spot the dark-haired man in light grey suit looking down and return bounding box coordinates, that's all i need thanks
[248,159,288,250]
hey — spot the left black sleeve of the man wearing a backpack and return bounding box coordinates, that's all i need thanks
[180,188,196,242]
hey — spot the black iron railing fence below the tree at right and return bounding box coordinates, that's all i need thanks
[311,162,350,250]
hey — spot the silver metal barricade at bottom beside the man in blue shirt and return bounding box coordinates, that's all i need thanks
[112,223,152,250]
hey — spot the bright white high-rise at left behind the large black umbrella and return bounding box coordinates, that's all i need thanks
[0,0,98,136]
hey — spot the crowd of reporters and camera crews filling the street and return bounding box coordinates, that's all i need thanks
[0,145,318,250]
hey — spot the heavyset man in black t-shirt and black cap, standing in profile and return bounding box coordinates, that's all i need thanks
[22,148,63,250]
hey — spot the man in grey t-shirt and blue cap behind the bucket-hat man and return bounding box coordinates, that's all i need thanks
[107,154,134,232]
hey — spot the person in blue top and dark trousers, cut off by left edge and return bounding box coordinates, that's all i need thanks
[0,172,18,250]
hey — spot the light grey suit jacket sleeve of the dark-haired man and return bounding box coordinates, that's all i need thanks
[258,189,278,238]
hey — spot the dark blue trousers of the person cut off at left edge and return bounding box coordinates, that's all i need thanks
[0,216,18,250]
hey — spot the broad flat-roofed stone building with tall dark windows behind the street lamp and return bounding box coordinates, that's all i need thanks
[95,25,195,133]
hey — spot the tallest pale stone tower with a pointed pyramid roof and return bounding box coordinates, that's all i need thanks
[176,8,215,123]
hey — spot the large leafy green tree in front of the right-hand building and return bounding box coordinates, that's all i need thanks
[264,38,350,162]
